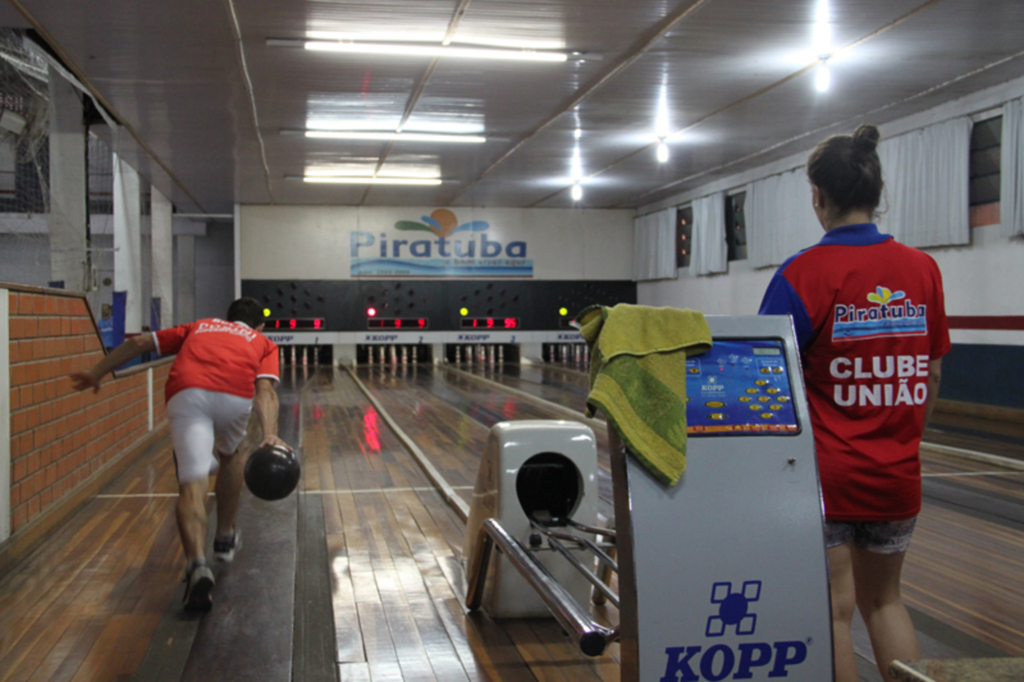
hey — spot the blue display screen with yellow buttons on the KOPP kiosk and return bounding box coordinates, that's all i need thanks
[686,339,800,435]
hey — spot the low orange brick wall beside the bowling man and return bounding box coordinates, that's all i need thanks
[9,291,170,534]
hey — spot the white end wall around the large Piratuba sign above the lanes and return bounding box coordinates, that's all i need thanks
[240,206,634,280]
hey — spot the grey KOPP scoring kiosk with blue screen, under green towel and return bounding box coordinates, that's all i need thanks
[611,316,833,682]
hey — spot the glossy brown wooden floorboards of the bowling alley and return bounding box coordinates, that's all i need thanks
[0,358,1024,682]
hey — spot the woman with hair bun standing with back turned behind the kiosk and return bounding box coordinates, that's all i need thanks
[760,125,949,682]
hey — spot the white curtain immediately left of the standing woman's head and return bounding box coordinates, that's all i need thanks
[744,166,824,267]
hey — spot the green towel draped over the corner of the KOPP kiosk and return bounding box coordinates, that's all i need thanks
[575,303,712,485]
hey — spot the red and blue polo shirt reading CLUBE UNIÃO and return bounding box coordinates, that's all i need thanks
[760,223,949,521]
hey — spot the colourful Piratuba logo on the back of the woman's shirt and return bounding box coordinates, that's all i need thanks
[833,285,928,341]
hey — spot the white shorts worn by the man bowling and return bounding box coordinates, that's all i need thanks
[167,388,253,483]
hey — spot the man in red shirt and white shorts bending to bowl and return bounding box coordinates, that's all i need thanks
[71,298,288,611]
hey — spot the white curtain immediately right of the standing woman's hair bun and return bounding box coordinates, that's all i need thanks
[879,118,972,247]
